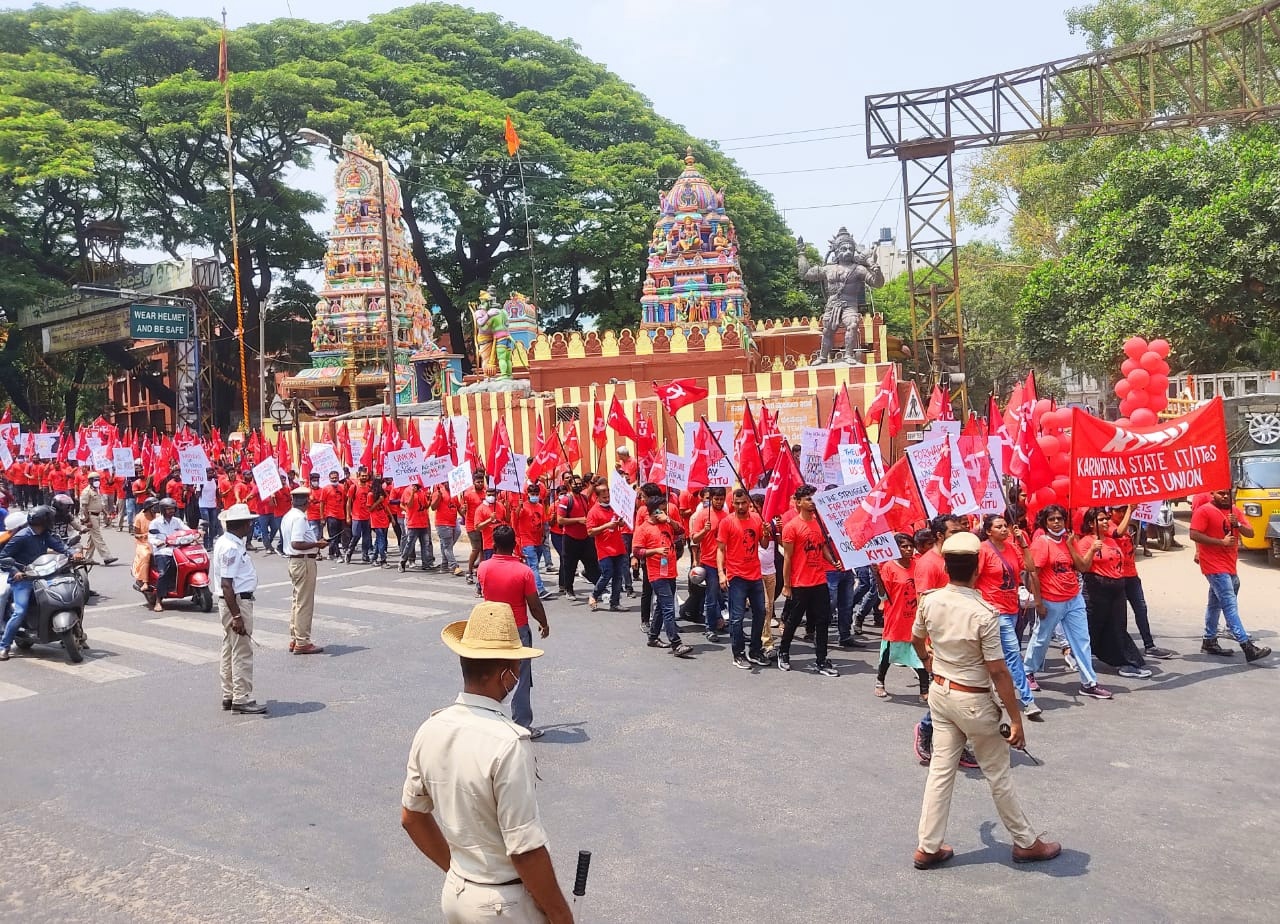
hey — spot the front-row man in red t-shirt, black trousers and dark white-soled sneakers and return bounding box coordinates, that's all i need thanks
[778,485,840,677]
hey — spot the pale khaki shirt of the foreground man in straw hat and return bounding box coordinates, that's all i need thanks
[402,691,547,884]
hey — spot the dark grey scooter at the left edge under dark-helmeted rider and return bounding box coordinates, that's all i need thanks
[0,540,93,664]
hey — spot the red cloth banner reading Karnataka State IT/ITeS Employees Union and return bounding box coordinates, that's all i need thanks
[1070,397,1231,507]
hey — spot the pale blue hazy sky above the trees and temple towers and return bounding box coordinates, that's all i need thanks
[67,0,1084,262]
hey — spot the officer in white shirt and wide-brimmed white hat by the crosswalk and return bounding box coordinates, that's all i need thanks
[209,504,266,715]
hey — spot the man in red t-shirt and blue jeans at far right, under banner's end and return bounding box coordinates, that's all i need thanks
[1190,490,1271,663]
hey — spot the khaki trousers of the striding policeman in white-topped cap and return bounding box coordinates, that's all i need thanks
[919,683,1036,854]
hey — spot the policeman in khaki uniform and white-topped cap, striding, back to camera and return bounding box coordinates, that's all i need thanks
[911,532,1062,869]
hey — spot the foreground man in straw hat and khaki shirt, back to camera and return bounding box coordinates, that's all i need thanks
[401,601,573,924]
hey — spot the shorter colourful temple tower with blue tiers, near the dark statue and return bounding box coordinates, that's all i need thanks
[640,148,751,329]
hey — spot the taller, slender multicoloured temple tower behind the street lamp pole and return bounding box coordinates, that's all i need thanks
[280,136,451,416]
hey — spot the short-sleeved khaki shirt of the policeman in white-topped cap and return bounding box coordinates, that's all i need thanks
[911,584,1005,687]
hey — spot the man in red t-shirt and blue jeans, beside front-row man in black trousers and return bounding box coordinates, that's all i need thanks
[716,488,769,671]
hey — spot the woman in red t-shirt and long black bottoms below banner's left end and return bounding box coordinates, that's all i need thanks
[1075,507,1151,680]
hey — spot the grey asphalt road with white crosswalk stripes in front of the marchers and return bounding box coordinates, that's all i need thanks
[0,517,1280,924]
